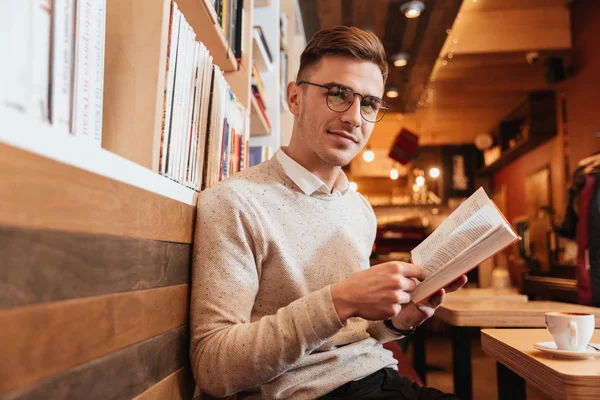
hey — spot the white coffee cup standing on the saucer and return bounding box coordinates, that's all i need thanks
[546,311,595,351]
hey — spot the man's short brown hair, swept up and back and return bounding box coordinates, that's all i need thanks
[298,25,388,84]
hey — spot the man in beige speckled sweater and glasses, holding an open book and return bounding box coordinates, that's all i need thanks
[190,27,466,399]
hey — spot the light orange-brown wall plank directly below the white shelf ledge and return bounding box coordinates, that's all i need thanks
[0,144,196,243]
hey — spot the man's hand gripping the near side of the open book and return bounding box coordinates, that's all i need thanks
[331,261,425,322]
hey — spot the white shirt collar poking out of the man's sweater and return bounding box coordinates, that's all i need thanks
[275,148,349,196]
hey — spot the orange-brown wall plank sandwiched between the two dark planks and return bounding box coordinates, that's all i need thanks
[0,286,189,392]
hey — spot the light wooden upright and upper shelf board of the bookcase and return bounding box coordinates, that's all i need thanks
[102,0,252,172]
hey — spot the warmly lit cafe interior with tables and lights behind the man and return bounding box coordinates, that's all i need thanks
[300,0,600,400]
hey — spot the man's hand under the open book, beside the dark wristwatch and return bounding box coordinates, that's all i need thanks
[392,275,467,330]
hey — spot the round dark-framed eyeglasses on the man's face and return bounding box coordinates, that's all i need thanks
[298,81,390,123]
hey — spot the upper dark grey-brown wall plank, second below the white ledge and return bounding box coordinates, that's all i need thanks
[0,226,192,309]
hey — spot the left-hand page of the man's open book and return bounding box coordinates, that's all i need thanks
[411,188,491,266]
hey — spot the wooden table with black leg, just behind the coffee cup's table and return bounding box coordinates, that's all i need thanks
[435,301,600,400]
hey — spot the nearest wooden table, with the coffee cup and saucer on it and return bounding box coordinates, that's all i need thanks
[481,329,600,400]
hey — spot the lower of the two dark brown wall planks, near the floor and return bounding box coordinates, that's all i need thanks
[0,325,189,400]
